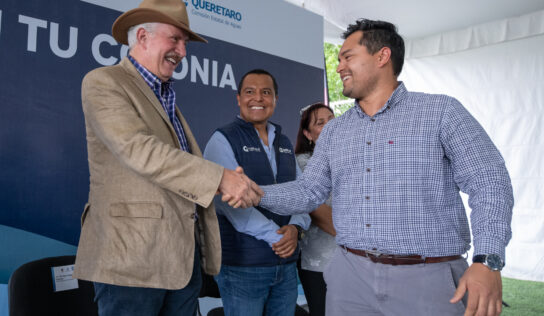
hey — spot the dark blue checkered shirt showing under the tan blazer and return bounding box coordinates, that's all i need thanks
[128,56,190,152]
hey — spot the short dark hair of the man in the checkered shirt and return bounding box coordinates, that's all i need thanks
[342,19,404,76]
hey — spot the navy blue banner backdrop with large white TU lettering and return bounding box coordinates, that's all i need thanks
[0,0,323,247]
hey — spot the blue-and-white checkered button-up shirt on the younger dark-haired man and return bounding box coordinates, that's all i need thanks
[261,82,514,260]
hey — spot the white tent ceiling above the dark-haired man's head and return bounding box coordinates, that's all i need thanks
[285,0,544,44]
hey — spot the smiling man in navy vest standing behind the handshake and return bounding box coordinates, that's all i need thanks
[204,69,310,316]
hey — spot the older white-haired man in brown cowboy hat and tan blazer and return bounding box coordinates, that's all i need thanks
[74,0,262,316]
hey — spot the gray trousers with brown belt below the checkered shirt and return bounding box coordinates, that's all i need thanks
[323,247,468,316]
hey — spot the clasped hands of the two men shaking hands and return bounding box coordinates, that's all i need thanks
[217,166,264,208]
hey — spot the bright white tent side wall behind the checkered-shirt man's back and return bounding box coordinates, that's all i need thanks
[401,11,544,281]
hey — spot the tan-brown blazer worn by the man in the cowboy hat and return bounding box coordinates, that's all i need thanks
[74,58,223,289]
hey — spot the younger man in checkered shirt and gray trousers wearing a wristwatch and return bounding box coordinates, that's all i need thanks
[231,19,513,315]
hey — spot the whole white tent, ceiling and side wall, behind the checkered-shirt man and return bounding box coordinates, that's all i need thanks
[288,0,544,281]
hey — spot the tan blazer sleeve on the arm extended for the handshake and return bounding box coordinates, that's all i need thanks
[81,67,223,207]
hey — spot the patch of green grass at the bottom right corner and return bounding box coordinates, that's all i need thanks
[501,278,544,316]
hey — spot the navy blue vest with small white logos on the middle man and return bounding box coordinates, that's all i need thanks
[217,118,299,266]
